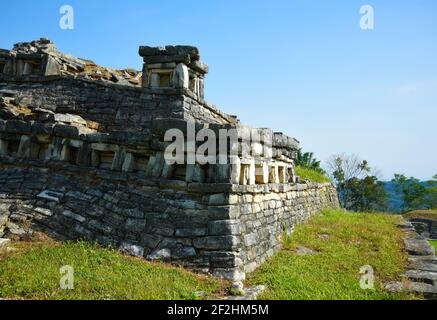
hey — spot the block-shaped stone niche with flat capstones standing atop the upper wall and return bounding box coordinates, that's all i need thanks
[139,46,208,99]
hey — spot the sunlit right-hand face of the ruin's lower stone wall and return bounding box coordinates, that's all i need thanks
[235,183,339,272]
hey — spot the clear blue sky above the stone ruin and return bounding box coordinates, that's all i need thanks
[0,0,437,179]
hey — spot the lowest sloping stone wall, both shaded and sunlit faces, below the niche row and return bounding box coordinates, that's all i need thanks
[0,160,338,280]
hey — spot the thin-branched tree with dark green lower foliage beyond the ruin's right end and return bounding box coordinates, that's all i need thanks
[327,154,388,211]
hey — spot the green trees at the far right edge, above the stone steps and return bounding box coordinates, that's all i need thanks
[392,174,437,211]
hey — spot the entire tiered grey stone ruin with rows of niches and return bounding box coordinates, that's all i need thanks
[0,39,338,280]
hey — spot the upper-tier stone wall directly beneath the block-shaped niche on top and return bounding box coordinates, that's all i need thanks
[0,76,237,132]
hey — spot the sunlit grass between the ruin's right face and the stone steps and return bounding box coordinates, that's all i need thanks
[249,210,417,300]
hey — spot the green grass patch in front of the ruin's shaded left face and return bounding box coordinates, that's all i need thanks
[0,242,225,300]
